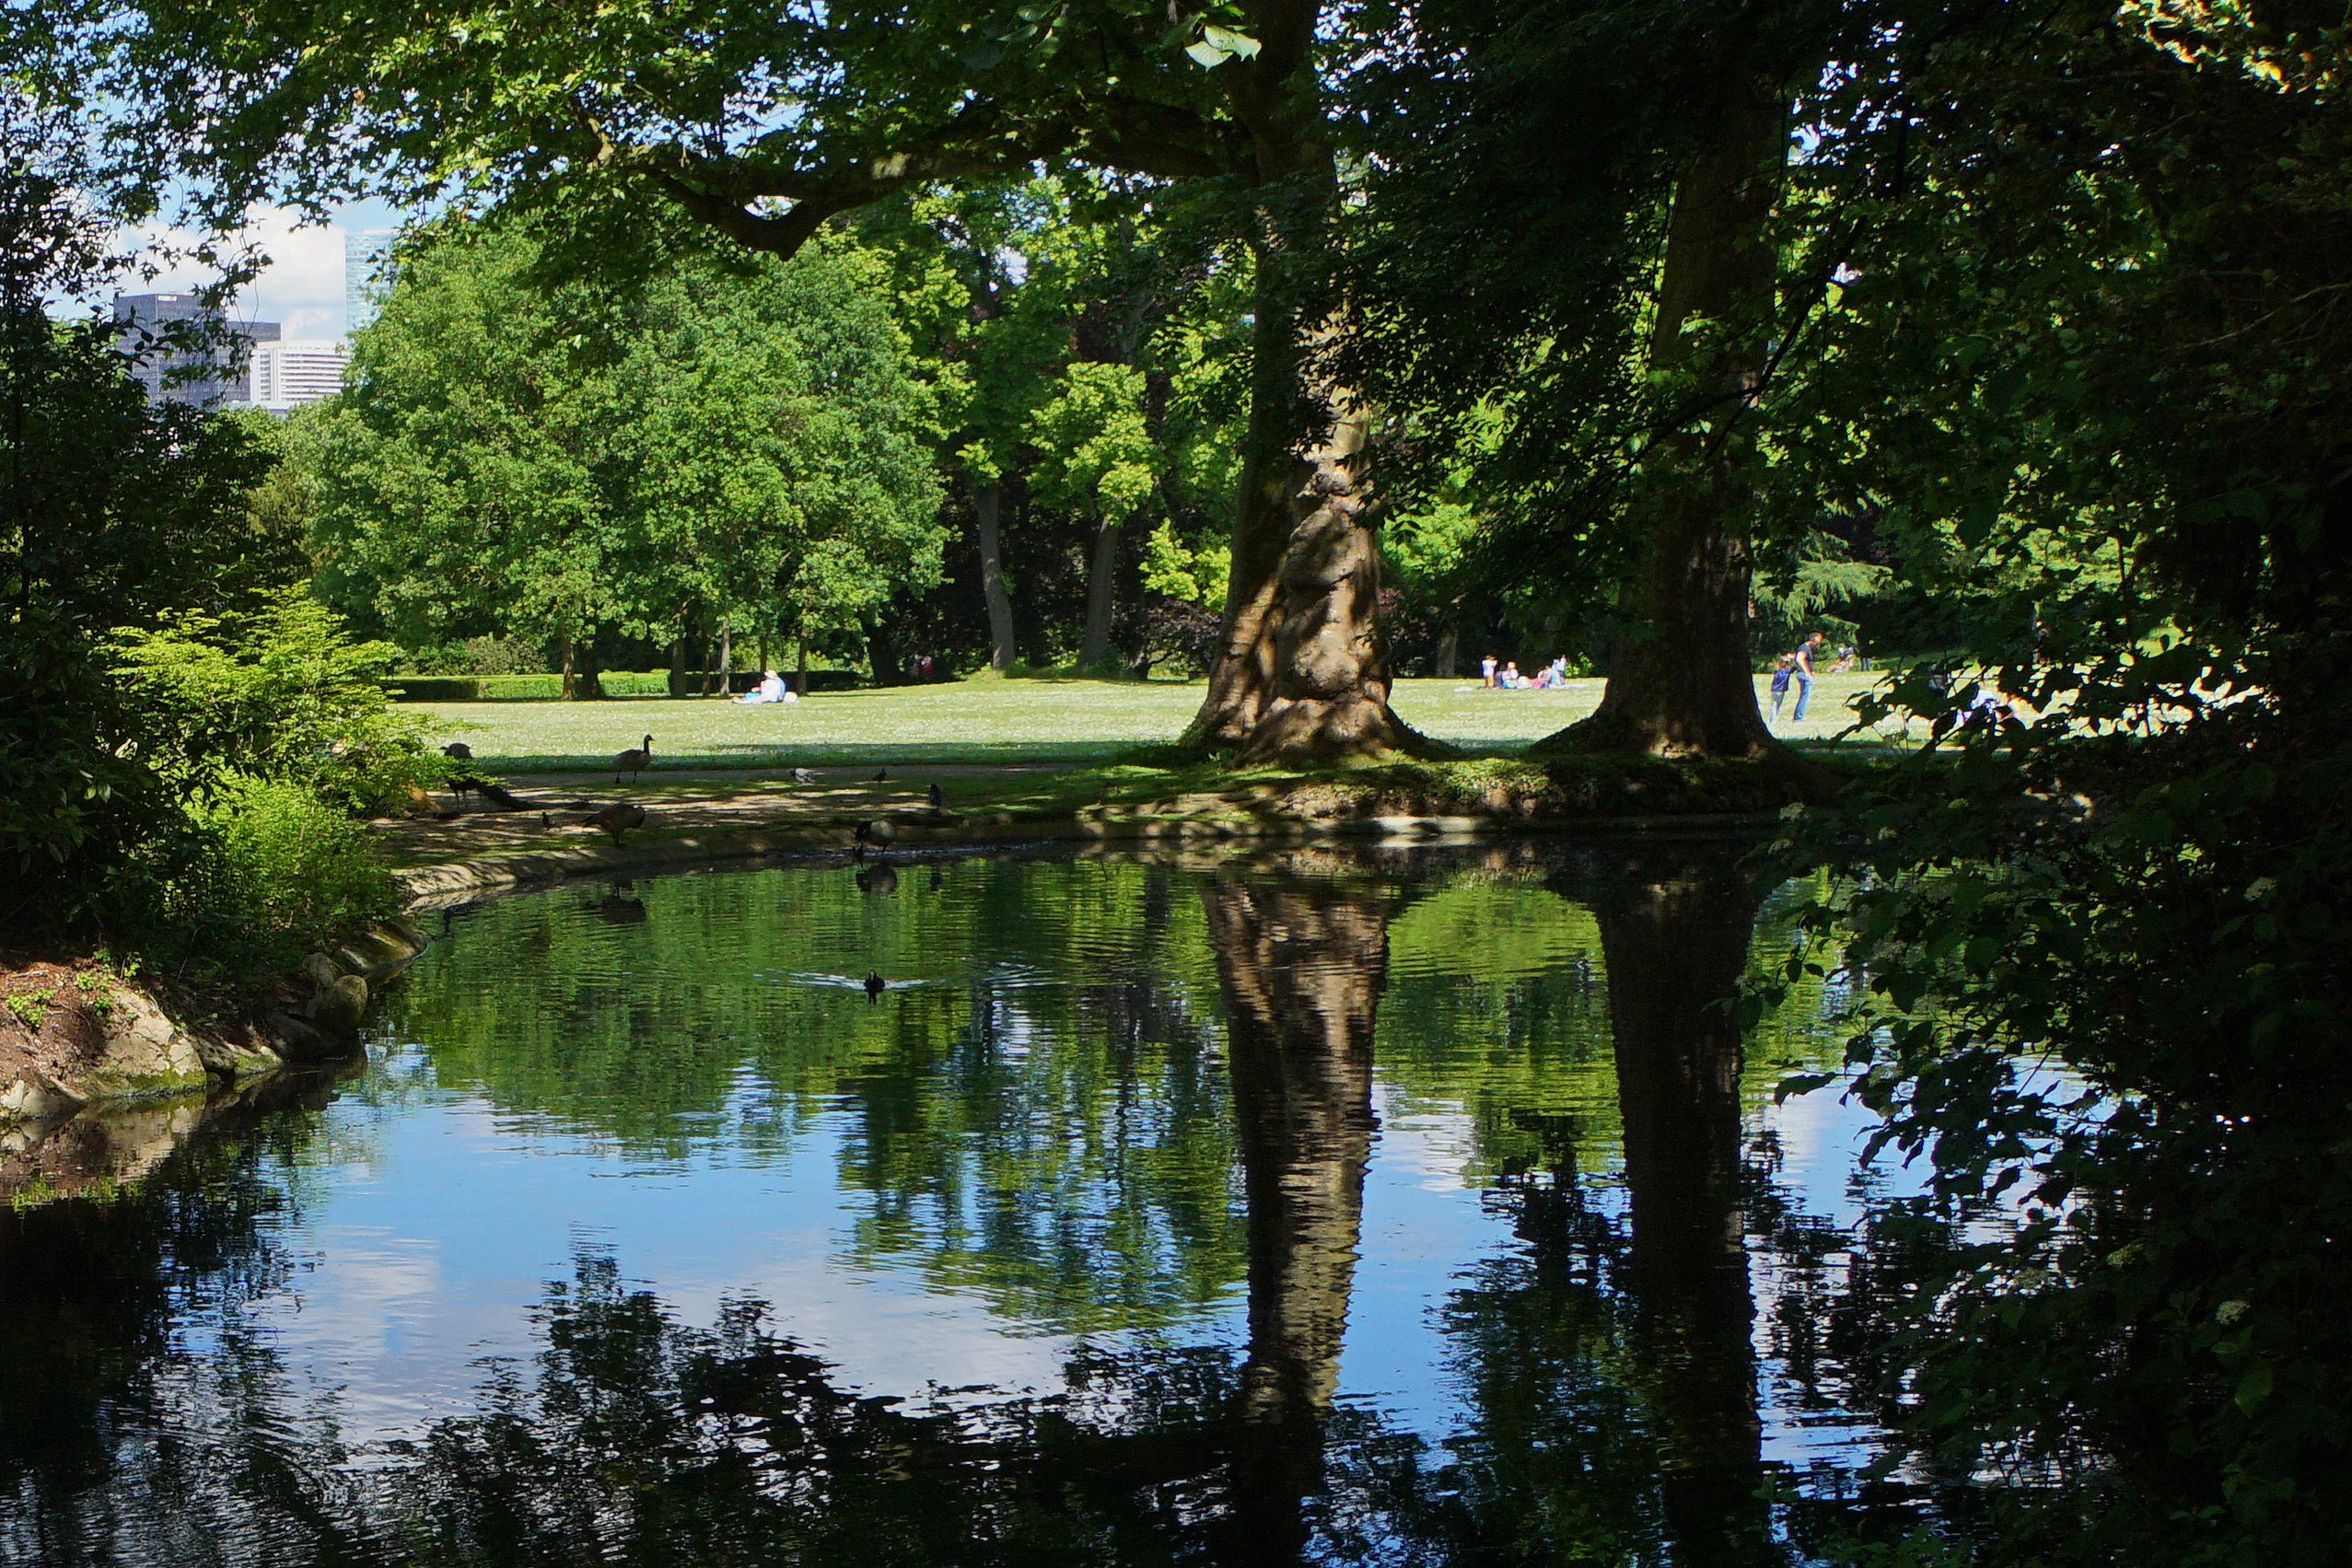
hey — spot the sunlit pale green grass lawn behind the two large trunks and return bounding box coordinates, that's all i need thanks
[409,675,1877,773]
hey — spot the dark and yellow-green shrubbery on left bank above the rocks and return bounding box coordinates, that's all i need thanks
[0,99,418,981]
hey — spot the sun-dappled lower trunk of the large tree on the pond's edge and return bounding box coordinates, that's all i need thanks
[1185,276,1426,761]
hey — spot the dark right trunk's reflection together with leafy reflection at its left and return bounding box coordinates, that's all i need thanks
[1395,855,1780,1568]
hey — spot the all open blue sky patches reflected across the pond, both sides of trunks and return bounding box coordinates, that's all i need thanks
[183,1046,1900,1465]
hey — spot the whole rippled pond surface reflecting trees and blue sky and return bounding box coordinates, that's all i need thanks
[0,844,1915,1565]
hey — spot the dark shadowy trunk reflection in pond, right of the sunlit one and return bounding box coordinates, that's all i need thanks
[1592,860,1771,1568]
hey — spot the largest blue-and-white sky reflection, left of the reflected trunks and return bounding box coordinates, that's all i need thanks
[191,1063,1194,1446]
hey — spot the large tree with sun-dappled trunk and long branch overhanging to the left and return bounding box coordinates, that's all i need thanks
[129,0,1409,755]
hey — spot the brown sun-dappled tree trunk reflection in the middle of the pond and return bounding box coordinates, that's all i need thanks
[1205,881,1392,1551]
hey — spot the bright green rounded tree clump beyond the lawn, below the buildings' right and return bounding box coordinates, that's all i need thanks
[303,221,941,696]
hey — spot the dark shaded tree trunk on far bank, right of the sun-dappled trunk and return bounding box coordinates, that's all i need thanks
[1538,82,1787,757]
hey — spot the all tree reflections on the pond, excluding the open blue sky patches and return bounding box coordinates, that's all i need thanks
[0,851,1909,1568]
